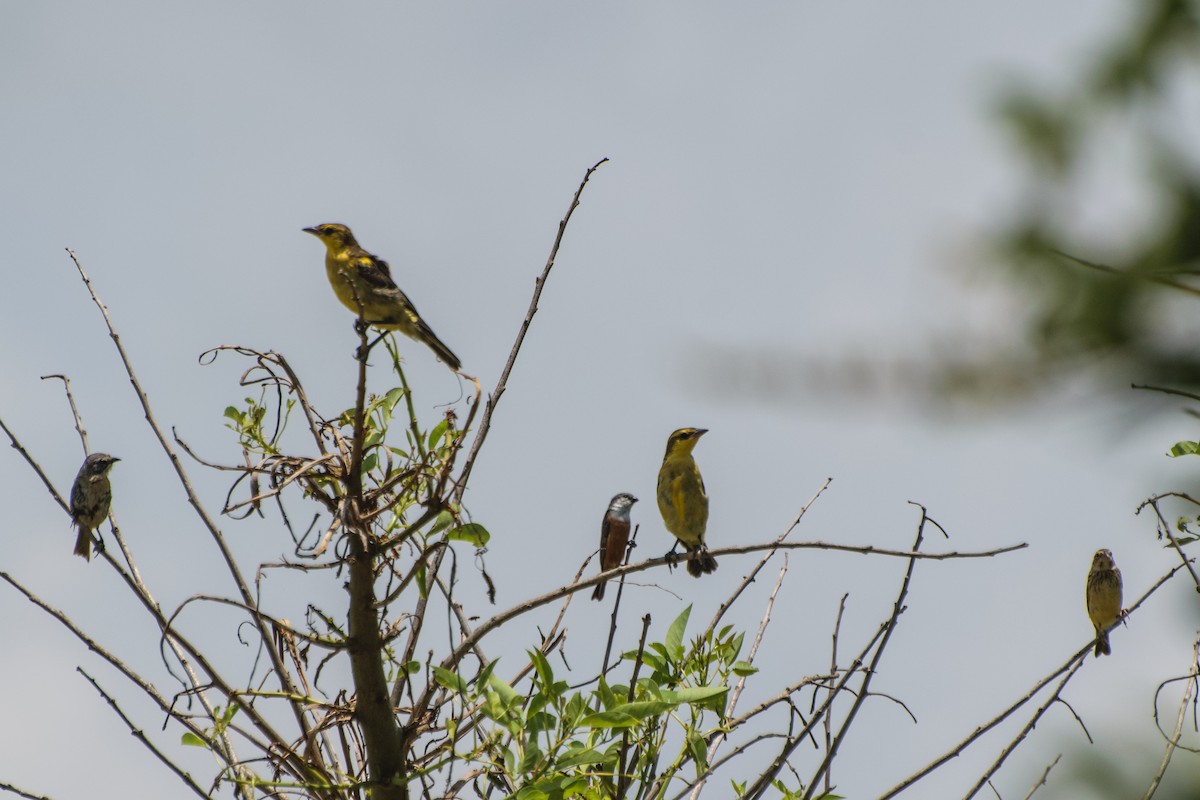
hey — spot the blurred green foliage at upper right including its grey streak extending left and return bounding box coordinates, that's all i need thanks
[680,0,1200,414]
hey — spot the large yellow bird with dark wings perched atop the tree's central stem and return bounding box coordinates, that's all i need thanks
[304,222,462,372]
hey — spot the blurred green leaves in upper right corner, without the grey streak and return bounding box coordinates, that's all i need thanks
[980,0,1200,398]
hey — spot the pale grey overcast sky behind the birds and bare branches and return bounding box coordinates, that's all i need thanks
[0,0,1195,800]
